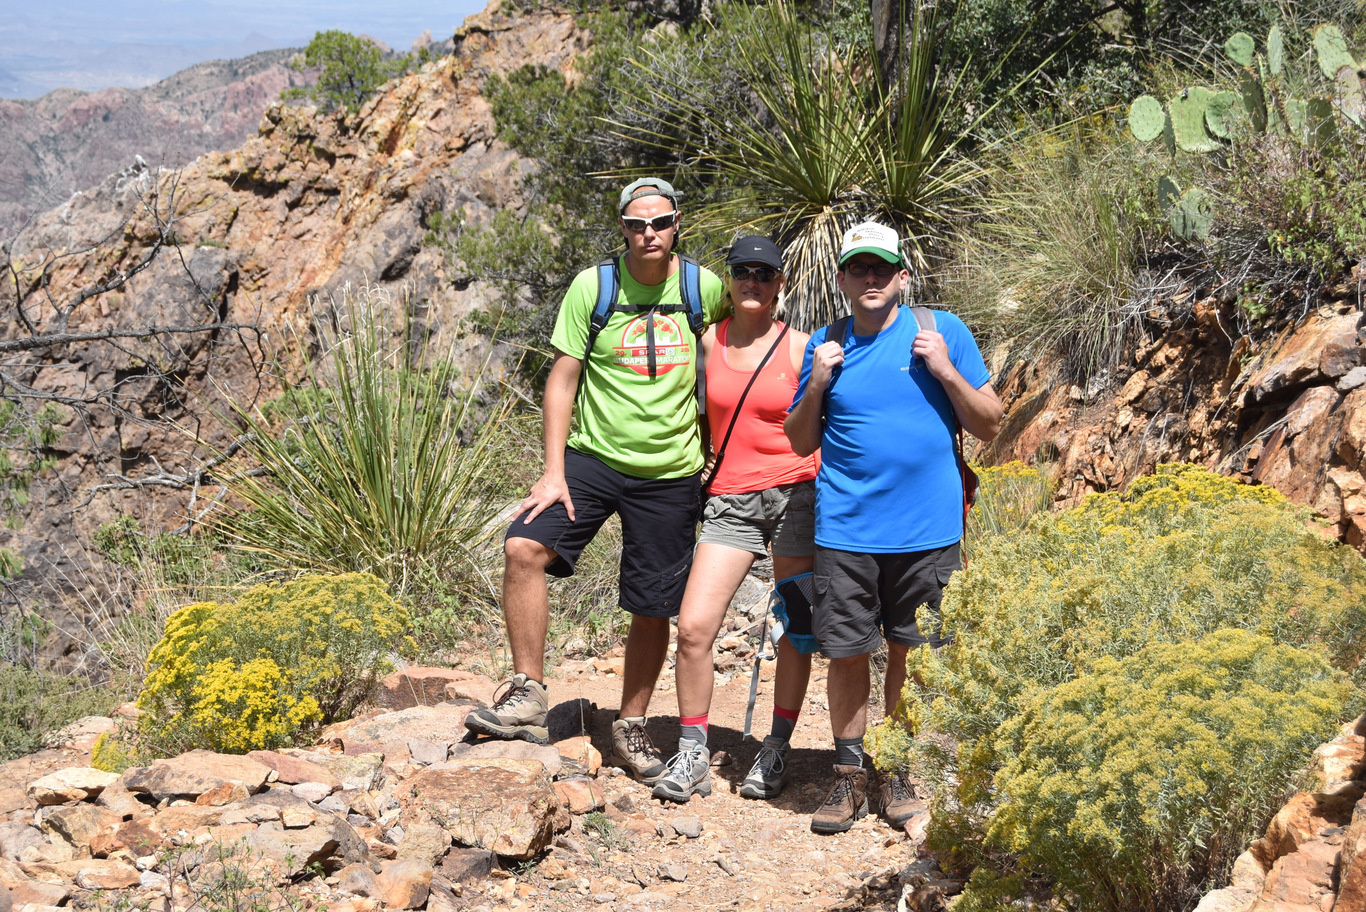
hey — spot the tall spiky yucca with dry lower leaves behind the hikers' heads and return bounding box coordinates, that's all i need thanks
[612,3,1027,329]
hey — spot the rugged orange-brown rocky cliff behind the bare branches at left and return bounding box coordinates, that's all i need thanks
[0,4,586,641]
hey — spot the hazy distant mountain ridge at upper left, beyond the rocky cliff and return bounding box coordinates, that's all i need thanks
[0,48,311,234]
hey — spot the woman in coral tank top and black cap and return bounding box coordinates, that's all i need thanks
[653,236,817,801]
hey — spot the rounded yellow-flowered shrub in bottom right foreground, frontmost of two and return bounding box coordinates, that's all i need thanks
[988,629,1352,912]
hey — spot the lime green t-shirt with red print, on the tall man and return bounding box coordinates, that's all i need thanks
[550,255,724,478]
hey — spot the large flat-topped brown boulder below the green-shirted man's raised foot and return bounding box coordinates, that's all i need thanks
[396,759,570,859]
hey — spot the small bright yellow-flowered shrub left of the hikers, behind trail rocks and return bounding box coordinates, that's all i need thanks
[138,573,408,754]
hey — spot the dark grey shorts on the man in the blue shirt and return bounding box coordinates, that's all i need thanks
[811,542,963,658]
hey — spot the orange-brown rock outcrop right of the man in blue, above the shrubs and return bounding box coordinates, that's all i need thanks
[982,265,1366,549]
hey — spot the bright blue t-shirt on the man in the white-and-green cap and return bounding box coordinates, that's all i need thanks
[792,304,990,554]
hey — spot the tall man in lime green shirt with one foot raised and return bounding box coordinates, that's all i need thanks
[464,177,723,782]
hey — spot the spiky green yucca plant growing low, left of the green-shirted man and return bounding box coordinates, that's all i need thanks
[210,282,511,611]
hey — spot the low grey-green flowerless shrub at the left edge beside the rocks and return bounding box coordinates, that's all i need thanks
[0,662,117,763]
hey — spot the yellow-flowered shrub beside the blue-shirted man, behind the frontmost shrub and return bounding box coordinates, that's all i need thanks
[899,466,1366,901]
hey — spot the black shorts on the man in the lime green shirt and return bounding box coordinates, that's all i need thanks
[507,449,702,617]
